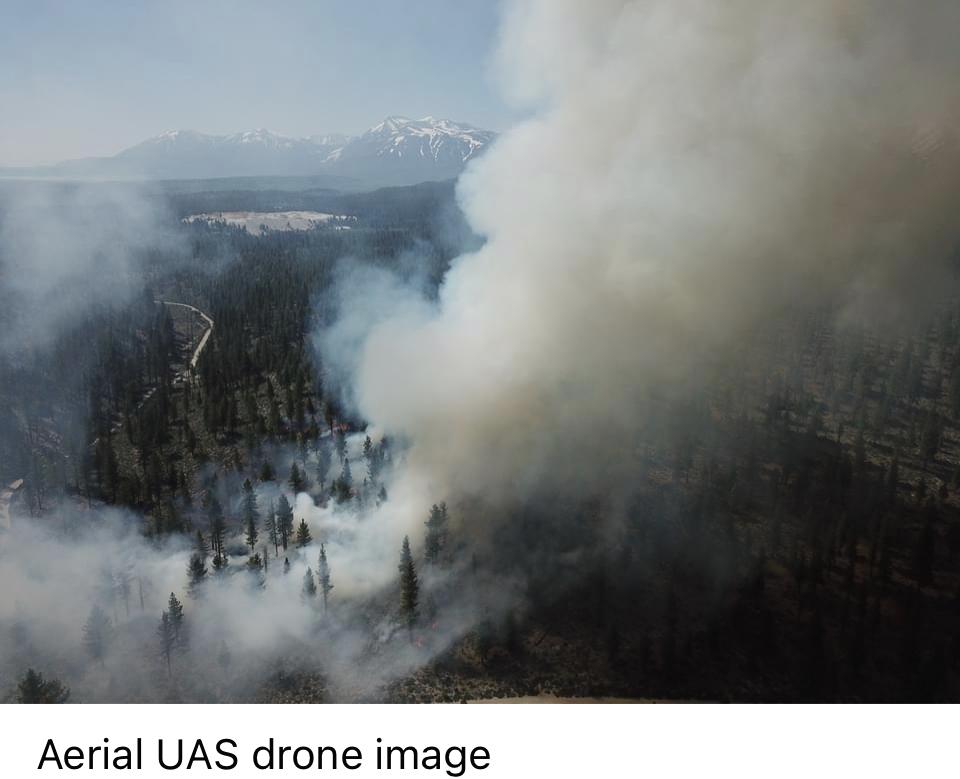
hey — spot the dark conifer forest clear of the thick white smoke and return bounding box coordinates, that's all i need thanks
[0,177,960,700]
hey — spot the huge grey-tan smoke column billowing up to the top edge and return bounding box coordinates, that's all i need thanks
[355,0,960,506]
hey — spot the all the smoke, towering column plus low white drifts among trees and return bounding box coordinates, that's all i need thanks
[0,0,960,700]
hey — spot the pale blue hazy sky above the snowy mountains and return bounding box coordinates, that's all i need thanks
[0,0,512,164]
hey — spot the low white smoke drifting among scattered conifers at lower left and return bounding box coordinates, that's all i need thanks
[0,435,521,702]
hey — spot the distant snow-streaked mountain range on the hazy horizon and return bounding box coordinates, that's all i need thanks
[0,116,496,189]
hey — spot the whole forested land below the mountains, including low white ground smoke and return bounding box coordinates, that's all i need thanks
[0,178,960,702]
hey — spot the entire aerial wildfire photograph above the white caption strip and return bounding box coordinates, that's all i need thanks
[0,0,960,703]
